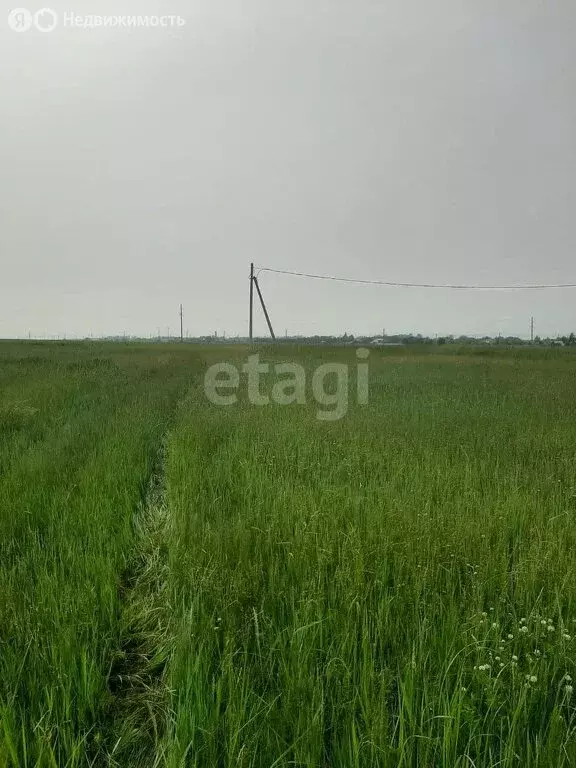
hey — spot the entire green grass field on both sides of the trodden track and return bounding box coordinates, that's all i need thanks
[0,342,576,768]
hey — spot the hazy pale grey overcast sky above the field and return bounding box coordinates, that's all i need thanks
[0,0,576,338]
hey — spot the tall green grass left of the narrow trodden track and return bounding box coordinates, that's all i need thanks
[0,345,200,768]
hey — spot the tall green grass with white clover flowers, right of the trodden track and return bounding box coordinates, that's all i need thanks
[159,350,576,768]
